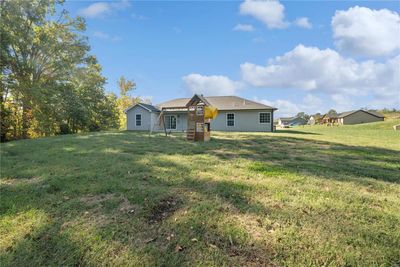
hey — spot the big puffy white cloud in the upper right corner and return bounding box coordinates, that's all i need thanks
[332,6,400,56]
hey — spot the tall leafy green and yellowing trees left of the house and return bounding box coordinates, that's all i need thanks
[0,0,139,142]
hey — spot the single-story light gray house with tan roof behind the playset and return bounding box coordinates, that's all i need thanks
[125,96,277,132]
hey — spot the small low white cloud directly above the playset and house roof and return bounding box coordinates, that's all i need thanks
[182,73,242,96]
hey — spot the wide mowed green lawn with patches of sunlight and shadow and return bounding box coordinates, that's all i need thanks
[0,120,400,266]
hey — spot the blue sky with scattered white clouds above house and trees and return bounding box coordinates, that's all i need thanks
[64,0,400,116]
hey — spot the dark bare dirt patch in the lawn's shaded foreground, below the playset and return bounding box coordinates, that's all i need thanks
[147,196,181,224]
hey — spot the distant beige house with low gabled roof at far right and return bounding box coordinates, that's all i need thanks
[337,109,385,125]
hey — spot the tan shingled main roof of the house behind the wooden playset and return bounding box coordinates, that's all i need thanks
[157,96,277,110]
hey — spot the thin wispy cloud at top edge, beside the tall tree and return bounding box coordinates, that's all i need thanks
[78,0,130,18]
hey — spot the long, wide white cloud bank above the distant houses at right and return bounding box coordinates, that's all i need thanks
[241,45,400,102]
